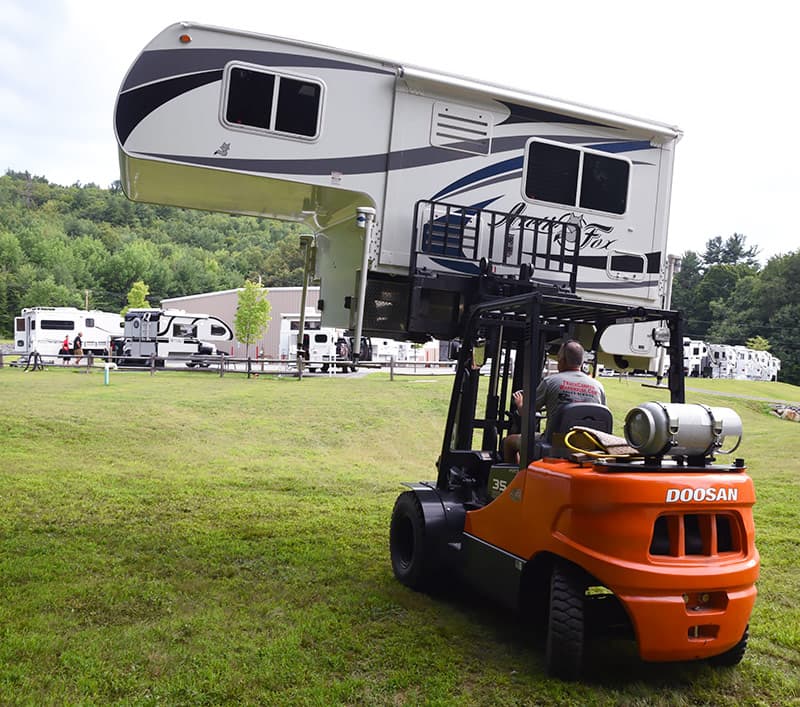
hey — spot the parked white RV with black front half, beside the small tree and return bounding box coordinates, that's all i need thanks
[114,309,233,367]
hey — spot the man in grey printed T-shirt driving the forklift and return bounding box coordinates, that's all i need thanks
[503,340,606,464]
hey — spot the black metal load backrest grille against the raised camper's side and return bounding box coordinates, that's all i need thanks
[410,201,581,293]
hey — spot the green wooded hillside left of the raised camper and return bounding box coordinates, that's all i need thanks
[0,171,302,336]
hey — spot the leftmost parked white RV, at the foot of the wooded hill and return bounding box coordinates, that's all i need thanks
[14,307,122,361]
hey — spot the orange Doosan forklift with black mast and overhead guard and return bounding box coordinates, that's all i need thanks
[390,291,759,680]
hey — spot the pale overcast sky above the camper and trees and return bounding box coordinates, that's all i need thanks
[0,0,800,260]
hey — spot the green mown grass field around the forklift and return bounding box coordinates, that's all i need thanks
[0,367,800,705]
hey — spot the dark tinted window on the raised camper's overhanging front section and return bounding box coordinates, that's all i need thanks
[225,66,322,138]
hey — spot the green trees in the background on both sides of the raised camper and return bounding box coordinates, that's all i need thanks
[0,171,800,384]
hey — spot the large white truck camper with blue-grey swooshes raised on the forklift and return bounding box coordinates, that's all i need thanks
[114,23,681,368]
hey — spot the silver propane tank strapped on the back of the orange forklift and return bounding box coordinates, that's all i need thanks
[625,402,742,457]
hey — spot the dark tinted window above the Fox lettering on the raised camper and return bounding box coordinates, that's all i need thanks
[524,140,630,214]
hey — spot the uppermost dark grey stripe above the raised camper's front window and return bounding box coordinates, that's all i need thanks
[120,48,395,92]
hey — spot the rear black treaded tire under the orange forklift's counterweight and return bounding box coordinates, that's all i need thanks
[545,562,586,680]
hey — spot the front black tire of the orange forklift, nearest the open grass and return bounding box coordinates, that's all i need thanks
[389,491,434,591]
